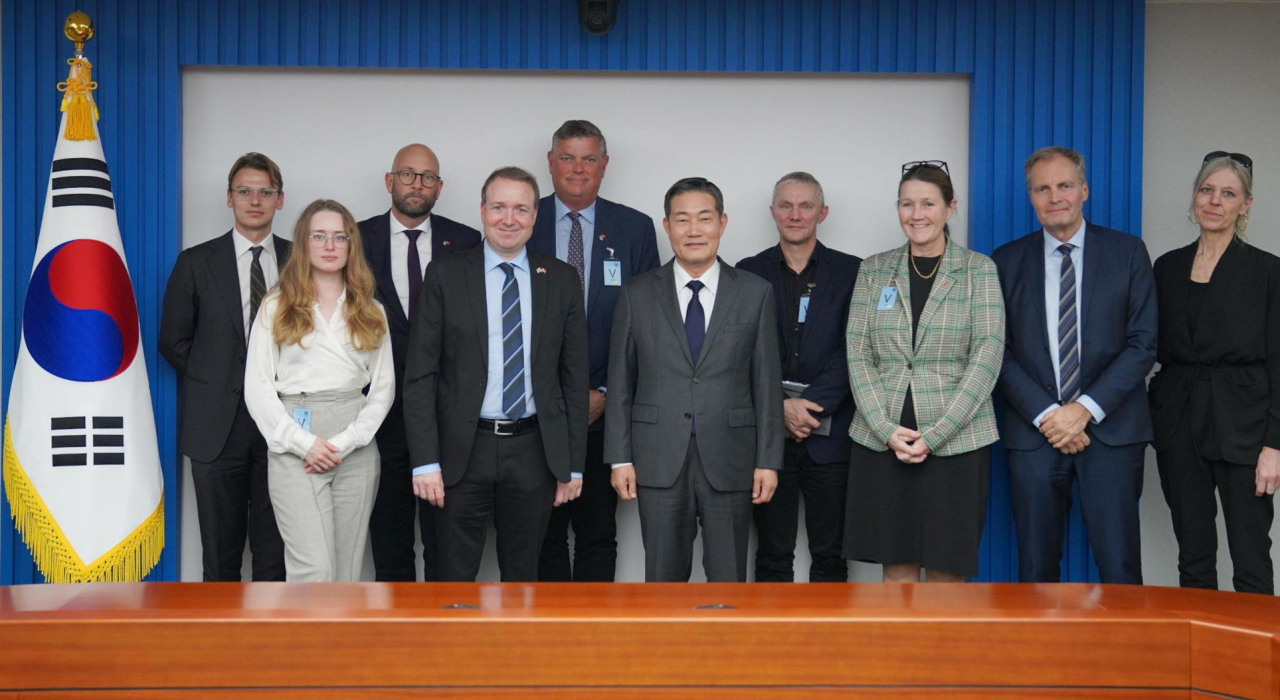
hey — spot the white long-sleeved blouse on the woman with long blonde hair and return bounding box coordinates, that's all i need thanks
[244,292,396,457]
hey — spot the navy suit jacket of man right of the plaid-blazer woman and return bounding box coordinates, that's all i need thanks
[991,224,1156,450]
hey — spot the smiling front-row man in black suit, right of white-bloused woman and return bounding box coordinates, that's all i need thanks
[404,168,588,581]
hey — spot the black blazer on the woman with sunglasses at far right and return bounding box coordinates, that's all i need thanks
[1149,242,1280,465]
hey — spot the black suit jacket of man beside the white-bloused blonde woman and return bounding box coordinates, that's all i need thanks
[404,247,588,486]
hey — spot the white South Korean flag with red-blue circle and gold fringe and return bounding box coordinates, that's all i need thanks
[4,103,164,582]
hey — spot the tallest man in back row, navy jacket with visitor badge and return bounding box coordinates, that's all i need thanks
[529,119,658,581]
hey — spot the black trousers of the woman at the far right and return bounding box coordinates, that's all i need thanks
[1156,430,1275,595]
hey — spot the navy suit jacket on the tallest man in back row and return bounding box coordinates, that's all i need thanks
[529,195,659,430]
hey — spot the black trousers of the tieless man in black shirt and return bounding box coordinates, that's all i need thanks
[753,440,849,582]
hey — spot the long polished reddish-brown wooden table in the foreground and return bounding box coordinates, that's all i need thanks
[0,584,1280,700]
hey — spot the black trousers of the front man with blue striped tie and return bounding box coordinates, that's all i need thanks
[435,427,556,581]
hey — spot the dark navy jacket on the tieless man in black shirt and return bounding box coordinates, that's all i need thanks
[737,242,863,465]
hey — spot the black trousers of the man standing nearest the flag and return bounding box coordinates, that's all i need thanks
[191,399,284,581]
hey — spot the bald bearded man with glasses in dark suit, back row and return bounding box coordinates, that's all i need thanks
[360,143,480,581]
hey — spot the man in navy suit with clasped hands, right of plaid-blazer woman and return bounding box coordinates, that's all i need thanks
[992,146,1156,584]
